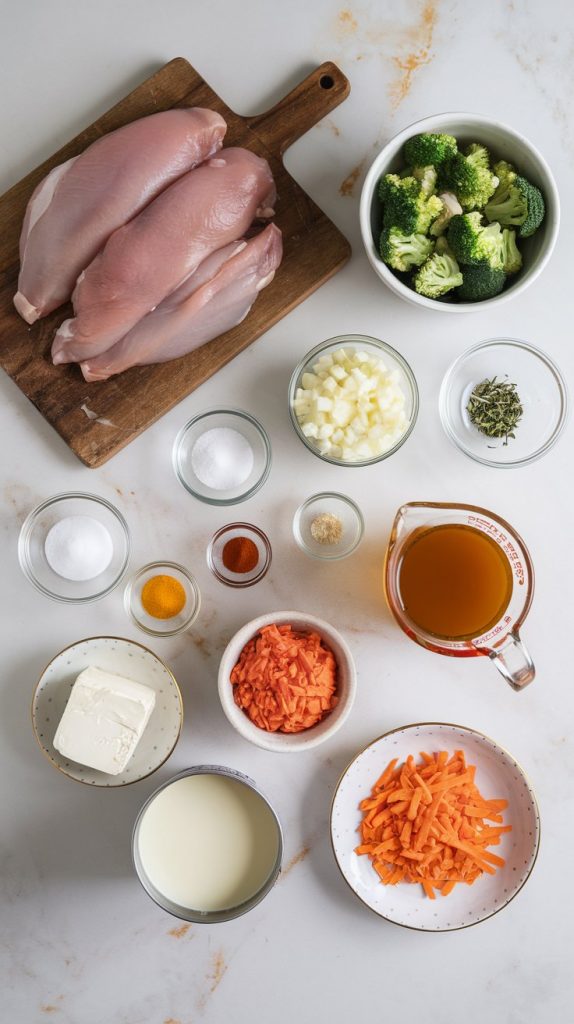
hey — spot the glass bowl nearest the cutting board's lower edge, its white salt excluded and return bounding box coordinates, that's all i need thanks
[173,409,271,506]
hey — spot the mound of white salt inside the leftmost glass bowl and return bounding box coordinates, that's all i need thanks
[44,515,114,583]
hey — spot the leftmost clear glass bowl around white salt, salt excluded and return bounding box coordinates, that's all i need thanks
[18,492,130,604]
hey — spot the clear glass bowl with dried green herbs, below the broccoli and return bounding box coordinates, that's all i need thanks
[439,338,568,468]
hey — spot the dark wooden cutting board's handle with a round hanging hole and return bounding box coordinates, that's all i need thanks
[247,60,351,155]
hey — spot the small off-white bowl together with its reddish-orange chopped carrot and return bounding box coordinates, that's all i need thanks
[218,611,357,754]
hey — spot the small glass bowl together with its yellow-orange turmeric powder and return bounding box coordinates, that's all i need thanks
[124,562,202,637]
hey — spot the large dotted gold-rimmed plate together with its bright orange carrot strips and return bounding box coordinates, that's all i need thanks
[330,722,540,932]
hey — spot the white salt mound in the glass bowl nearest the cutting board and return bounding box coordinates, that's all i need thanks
[191,427,255,490]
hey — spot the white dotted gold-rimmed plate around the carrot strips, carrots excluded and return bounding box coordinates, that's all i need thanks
[330,722,540,932]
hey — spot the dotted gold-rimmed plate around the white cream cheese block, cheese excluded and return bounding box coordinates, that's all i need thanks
[32,637,183,786]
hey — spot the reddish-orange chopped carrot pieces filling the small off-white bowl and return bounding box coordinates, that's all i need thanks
[230,625,335,733]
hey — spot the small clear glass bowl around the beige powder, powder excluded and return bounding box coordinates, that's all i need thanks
[293,490,364,561]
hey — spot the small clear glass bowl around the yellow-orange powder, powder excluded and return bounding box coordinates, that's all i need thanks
[124,562,202,637]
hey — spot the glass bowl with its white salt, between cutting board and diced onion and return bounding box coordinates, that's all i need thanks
[173,409,271,506]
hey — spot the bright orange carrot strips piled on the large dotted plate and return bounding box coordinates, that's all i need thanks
[355,751,512,899]
